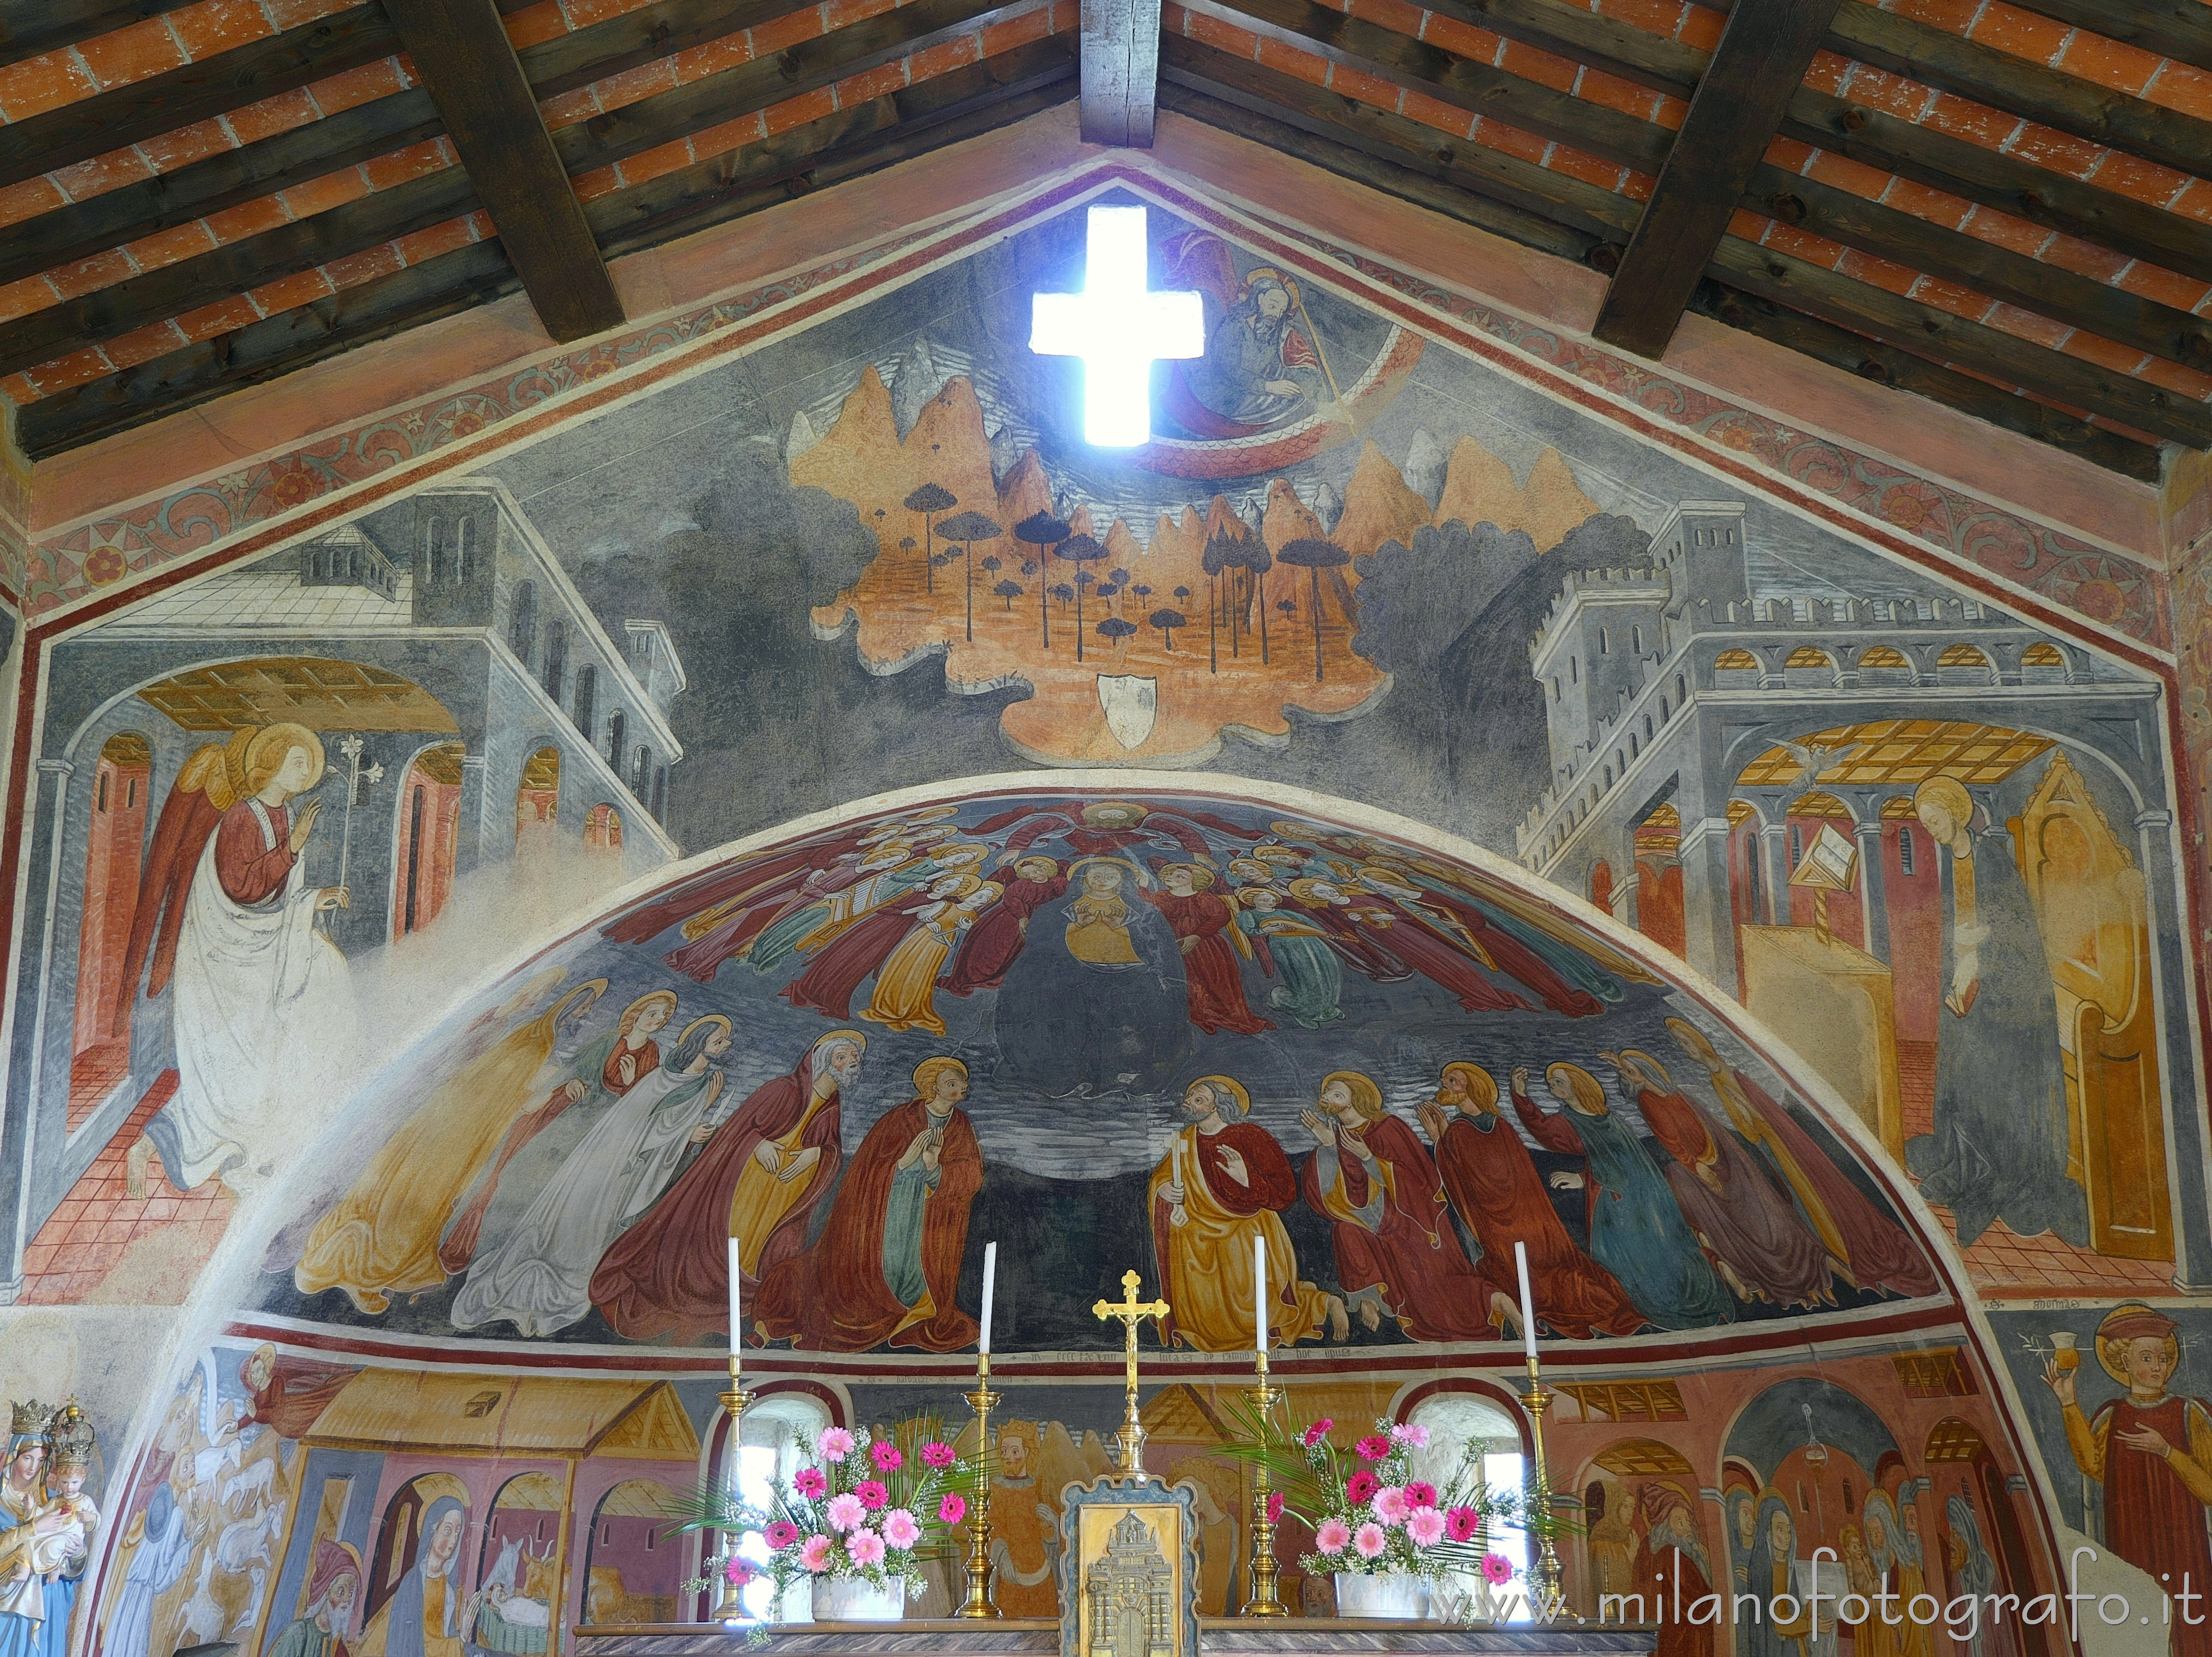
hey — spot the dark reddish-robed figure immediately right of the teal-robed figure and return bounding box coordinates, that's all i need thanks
[1604,1049,1836,1307]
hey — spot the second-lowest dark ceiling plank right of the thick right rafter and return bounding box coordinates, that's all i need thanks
[1710,237,2212,449]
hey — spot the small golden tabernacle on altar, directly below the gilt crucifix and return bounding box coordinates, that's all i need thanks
[1059,1476,1199,1657]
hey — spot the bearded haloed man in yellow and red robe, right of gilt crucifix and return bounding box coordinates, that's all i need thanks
[1146,1075,1351,1352]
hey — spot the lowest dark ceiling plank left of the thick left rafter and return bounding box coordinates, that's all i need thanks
[15,239,522,460]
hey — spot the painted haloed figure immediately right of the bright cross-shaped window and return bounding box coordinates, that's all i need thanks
[1161,230,1336,438]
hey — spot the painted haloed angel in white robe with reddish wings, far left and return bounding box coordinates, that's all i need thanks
[120,724,354,1195]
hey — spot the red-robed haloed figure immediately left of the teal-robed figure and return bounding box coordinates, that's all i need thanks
[1420,1062,1643,1341]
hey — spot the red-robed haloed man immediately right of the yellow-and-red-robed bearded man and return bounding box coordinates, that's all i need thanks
[1299,1071,1489,1341]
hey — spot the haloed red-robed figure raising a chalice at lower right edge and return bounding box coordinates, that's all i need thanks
[2044,1301,2212,1657]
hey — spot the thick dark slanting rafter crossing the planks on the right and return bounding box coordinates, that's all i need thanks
[1591,0,1836,361]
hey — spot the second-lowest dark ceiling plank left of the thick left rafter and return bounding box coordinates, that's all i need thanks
[0,166,478,385]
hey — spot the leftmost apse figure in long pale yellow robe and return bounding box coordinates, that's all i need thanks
[292,978,606,1314]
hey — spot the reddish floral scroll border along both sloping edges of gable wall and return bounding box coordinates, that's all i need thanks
[20,164,2172,653]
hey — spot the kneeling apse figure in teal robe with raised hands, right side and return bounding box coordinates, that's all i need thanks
[1513,1064,1737,1330]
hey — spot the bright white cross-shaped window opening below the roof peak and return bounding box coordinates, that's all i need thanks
[1029,208,1205,449]
